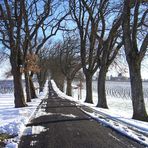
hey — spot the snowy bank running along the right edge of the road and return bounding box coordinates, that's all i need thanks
[52,81,148,146]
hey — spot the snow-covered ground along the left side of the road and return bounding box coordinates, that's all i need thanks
[0,82,48,148]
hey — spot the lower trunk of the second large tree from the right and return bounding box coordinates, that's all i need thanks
[97,67,108,108]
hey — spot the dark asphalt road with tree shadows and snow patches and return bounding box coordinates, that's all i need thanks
[18,83,144,148]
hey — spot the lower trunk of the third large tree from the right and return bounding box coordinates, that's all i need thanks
[85,74,93,103]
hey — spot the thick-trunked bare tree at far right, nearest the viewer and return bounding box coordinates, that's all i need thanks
[122,0,148,121]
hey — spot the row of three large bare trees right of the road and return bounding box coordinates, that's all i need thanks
[70,0,148,120]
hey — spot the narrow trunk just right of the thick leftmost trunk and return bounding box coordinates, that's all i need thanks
[25,72,31,102]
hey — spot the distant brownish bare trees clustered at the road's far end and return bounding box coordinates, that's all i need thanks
[37,32,82,96]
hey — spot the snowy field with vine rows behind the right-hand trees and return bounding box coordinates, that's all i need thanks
[72,81,148,118]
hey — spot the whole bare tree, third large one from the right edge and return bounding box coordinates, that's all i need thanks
[70,0,99,103]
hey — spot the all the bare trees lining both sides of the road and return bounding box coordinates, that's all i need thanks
[0,0,148,120]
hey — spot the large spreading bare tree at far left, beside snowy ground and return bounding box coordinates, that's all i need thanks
[0,0,67,107]
